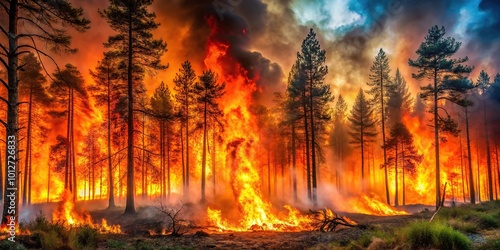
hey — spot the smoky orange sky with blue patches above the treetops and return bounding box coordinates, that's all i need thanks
[54,0,500,106]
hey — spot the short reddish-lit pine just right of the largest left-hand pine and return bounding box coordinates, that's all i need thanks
[150,82,174,200]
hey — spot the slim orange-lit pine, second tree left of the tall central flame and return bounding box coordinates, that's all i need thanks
[174,61,196,199]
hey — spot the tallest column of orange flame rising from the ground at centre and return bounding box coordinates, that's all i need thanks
[204,18,310,231]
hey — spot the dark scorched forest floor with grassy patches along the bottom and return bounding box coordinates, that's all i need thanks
[5,202,500,249]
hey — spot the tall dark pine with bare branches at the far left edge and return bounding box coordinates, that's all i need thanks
[0,0,90,229]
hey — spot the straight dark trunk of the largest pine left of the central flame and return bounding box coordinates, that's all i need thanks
[125,2,135,214]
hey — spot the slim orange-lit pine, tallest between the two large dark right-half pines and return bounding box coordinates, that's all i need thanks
[367,49,392,204]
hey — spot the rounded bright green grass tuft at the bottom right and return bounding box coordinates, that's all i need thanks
[405,221,472,250]
